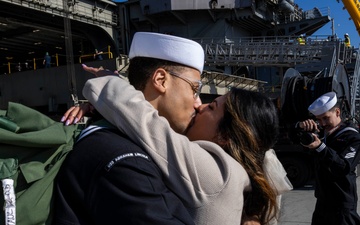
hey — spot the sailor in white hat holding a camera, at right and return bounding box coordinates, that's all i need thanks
[298,92,360,225]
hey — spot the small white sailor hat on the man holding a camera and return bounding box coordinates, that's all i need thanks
[308,92,337,116]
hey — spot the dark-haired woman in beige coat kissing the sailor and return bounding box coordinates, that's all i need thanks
[65,68,292,224]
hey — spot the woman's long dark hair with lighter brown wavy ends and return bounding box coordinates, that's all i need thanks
[218,88,279,224]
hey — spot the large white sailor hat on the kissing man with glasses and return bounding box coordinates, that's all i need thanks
[129,32,205,73]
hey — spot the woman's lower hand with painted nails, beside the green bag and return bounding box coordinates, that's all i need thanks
[61,103,94,126]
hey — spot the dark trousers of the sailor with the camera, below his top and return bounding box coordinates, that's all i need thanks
[311,201,360,225]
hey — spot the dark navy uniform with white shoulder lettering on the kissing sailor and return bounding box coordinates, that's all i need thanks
[55,129,194,225]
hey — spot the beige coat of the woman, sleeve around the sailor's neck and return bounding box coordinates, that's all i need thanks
[83,76,250,225]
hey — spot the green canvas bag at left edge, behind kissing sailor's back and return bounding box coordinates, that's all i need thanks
[0,103,79,225]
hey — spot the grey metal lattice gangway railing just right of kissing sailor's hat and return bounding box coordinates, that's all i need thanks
[195,37,335,67]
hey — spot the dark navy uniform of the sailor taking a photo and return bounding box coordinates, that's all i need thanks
[312,123,360,225]
